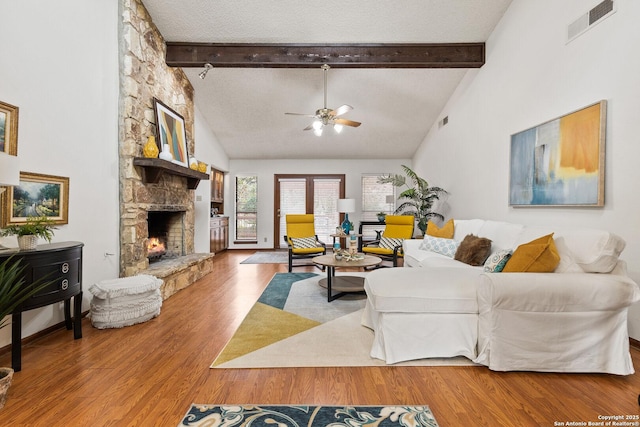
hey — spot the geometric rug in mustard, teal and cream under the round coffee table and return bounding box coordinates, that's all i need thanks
[211,272,475,369]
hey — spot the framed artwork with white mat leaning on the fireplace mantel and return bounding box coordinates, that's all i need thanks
[153,98,189,167]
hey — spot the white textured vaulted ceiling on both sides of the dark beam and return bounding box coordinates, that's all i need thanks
[143,0,511,159]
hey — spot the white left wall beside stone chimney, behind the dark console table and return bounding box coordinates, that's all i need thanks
[0,0,119,345]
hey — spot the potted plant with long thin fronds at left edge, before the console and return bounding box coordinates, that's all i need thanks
[0,255,52,409]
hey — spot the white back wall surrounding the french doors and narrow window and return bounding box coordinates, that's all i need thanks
[225,159,412,249]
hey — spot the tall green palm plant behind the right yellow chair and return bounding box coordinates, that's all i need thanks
[378,165,448,234]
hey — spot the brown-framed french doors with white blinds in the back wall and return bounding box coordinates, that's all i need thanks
[273,175,344,248]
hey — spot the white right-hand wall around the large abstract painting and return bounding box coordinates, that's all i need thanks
[414,0,640,339]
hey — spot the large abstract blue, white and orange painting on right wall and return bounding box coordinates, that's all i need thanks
[509,100,607,207]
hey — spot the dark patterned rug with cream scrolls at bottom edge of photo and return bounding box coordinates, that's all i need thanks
[178,403,438,427]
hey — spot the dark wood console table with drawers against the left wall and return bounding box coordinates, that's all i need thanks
[0,242,84,372]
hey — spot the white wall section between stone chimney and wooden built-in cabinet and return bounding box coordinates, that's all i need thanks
[193,107,232,253]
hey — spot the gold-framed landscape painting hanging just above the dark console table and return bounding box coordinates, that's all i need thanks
[2,172,69,227]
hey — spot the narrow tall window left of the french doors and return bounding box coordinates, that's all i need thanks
[236,176,258,241]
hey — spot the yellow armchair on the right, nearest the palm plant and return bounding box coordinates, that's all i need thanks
[362,215,415,267]
